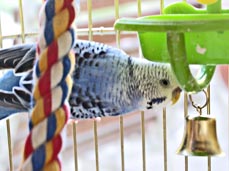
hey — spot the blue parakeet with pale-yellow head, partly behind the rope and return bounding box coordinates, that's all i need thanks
[0,40,181,119]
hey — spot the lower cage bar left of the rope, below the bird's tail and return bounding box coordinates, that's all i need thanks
[6,119,14,171]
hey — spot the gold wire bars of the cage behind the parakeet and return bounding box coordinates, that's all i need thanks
[0,0,228,171]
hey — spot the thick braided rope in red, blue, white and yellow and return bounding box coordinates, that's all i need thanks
[21,0,75,171]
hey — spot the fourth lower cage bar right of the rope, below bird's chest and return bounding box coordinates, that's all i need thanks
[141,111,146,171]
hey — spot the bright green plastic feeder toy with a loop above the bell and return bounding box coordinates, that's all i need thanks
[115,0,229,92]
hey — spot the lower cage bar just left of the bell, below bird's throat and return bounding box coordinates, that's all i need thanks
[163,108,168,171]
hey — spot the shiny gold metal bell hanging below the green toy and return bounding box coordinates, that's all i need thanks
[177,115,224,156]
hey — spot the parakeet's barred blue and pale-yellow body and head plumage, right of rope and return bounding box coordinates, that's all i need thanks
[69,41,177,118]
